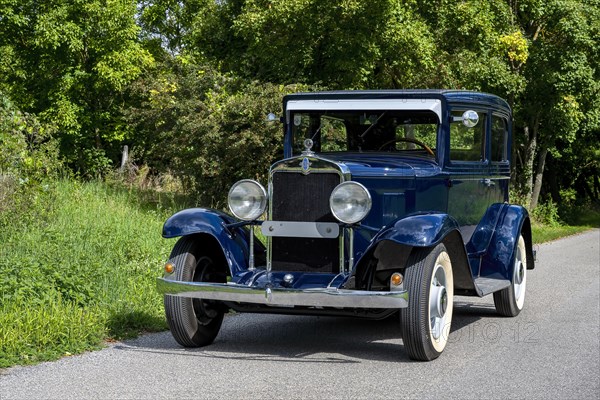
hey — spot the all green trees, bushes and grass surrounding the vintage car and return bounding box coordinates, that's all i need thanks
[0,0,600,367]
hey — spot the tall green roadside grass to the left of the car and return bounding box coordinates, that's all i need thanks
[0,181,177,367]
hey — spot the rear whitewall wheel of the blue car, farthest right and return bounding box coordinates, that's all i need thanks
[494,236,527,317]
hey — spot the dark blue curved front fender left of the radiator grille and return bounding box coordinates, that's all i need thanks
[162,208,264,276]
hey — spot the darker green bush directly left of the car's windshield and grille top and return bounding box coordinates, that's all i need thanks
[127,59,314,206]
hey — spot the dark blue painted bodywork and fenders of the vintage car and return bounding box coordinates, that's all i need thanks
[163,90,533,296]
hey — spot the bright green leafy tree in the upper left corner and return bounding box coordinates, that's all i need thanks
[0,0,153,175]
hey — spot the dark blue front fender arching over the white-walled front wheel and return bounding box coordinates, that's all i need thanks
[355,213,475,291]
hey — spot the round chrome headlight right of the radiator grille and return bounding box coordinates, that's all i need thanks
[329,181,371,224]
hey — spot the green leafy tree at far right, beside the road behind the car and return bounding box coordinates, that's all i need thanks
[514,0,600,209]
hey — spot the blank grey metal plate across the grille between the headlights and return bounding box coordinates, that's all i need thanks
[260,221,340,239]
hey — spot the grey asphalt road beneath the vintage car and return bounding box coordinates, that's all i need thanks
[0,229,600,400]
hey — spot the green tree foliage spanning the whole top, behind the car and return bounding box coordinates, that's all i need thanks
[0,0,600,206]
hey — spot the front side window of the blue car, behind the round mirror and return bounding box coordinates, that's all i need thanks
[450,110,486,161]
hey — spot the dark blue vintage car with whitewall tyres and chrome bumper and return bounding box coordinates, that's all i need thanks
[158,90,534,360]
